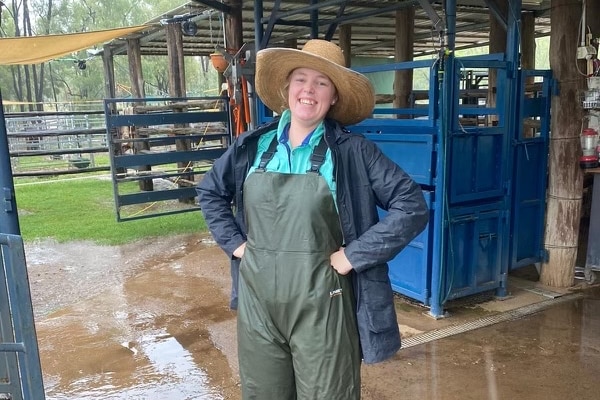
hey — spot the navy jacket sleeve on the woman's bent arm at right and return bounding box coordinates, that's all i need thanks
[345,139,429,272]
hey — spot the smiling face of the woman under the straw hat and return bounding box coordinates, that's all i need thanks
[288,68,337,129]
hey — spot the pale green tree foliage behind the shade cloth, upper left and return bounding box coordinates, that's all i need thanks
[0,0,218,111]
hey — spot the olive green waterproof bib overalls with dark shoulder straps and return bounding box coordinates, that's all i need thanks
[238,138,360,400]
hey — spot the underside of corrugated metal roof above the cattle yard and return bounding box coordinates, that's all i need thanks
[105,0,550,57]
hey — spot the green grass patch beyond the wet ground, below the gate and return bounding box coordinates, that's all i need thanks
[15,178,206,245]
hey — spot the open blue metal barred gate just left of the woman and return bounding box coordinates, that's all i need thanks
[104,97,232,222]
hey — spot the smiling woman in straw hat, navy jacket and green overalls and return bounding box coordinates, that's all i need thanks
[198,39,429,400]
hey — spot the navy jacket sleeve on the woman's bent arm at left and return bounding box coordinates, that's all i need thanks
[196,142,246,258]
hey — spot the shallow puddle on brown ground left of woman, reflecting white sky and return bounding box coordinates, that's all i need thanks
[31,234,239,400]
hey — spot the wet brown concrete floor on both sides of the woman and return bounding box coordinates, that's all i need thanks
[26,235,600,400]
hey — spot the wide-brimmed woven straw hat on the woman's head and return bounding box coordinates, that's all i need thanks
[255,39,375,125]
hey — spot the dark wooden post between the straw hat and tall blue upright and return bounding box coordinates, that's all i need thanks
[394,7,415,118]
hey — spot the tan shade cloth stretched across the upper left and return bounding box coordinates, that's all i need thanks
[0,25,149,65]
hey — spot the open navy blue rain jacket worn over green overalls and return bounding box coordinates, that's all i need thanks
[197,119,429,363]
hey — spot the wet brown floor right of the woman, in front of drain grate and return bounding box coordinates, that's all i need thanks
[363,293,600,400]
